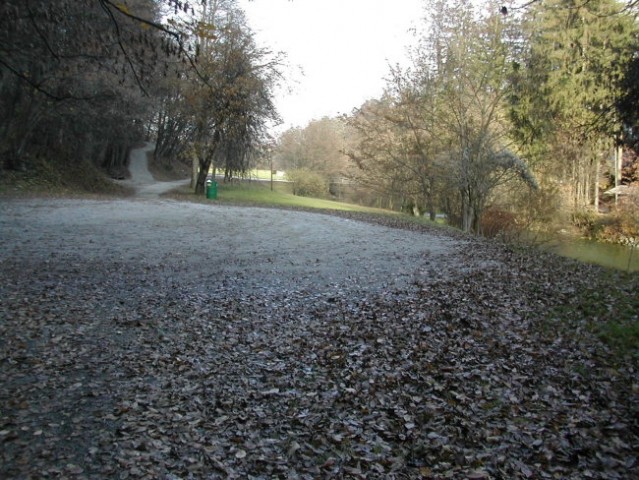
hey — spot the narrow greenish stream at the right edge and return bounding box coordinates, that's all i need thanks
[542,236,639,272]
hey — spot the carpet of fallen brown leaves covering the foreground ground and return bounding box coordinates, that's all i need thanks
[0,232,639,479]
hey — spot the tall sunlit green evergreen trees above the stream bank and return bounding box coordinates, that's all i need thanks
[511,0,636,209]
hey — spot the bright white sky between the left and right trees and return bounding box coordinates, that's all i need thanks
[239,0,423,131]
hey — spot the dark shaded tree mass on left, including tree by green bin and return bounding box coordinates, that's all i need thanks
[0,0,279,192]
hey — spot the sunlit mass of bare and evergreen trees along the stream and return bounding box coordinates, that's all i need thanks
[340,0,638,233]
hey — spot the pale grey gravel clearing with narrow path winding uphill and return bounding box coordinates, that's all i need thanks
[0,142,476,292]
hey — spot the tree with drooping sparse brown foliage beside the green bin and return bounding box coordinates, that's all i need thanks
[150,0,281,193]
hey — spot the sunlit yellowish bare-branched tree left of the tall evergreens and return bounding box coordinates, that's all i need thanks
[351,0,535,233]
